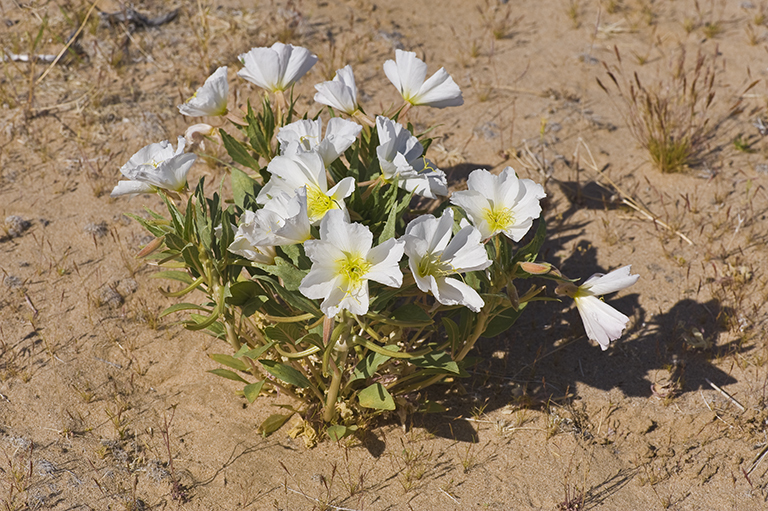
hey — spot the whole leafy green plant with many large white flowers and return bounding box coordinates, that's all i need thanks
[112,43,637,443]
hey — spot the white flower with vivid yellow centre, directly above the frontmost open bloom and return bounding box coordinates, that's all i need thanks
[256,153,355,224]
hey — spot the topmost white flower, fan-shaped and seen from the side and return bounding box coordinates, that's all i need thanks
[237,43,317,92]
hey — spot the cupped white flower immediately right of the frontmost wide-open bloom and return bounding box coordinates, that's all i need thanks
[401,209,491,312]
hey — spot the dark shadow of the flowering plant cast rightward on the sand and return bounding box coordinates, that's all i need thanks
[414,214,748,442]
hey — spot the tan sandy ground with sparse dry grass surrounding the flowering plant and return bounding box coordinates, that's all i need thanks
[0,0,768,510]
